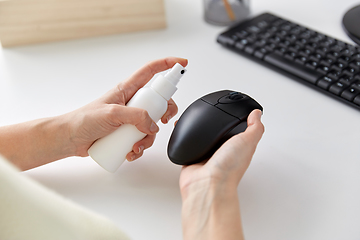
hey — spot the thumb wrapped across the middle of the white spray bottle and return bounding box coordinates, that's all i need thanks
[105,104,159,135]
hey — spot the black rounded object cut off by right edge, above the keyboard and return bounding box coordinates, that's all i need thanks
[342,5,360,45]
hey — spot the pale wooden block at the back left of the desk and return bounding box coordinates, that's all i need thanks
[0,0,166,47]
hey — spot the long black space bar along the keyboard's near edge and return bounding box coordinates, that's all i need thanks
[264,53,323,84]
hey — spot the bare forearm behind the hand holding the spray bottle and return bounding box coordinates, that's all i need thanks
[0,116,75,170]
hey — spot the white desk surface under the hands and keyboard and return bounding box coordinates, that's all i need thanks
[0,0,360,240]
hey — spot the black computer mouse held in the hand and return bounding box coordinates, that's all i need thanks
[167,90,263,165]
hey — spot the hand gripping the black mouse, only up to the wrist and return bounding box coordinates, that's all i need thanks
[180,110,264,192]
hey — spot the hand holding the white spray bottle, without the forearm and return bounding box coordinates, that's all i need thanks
[67,57,187,161]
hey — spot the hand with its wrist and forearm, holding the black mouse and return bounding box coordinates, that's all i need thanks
[180,110,264,240]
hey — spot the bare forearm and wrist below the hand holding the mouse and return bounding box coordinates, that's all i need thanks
[182,180,244,240]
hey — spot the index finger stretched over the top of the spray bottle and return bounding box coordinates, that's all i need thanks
[122,57,188,101]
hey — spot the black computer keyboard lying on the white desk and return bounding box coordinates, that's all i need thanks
[217,13,360,110]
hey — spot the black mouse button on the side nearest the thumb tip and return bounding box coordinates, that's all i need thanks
[216,97,263,121]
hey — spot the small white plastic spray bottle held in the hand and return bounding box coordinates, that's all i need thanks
[88,63,186,172]
